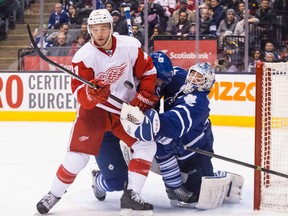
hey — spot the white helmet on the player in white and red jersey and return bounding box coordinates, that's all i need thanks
[87,9,113,34]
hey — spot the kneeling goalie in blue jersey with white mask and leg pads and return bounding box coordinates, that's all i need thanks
[121,63,244,209]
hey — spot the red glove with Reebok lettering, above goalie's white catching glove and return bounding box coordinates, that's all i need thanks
[130,90,160,112]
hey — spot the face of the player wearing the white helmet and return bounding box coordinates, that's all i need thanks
[90,23,111,46]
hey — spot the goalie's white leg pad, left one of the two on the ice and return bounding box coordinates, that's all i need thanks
[196,176,230,209]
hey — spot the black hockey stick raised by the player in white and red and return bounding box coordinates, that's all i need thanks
[27,24,125,104]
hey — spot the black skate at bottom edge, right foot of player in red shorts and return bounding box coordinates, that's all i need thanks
[120,190,153,216]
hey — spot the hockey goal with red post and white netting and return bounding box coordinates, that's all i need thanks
[254,62,288,212]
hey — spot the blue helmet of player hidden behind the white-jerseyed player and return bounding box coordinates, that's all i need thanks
[150,51,173,88]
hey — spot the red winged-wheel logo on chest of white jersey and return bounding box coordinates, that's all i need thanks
[97,62,127,84]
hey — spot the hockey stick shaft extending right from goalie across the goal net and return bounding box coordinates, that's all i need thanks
[184,146,288,178]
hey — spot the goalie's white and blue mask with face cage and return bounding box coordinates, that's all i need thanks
[184,62,215,93]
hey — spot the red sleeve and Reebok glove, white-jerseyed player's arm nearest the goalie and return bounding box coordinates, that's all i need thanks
[130,48,159,111]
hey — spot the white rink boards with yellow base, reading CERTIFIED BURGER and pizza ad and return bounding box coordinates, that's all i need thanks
[0,71,255,127]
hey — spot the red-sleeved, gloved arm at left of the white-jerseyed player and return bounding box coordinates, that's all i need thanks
[71,62,110,109]
